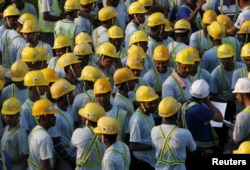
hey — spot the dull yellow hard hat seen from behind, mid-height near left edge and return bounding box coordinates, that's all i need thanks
[10,60,29,82]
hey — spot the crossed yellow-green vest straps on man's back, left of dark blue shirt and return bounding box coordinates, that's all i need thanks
[156,126,185,165]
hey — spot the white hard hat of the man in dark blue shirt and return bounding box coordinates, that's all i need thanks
[190,79,210,99]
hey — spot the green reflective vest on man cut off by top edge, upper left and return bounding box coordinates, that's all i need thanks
[38,0,62,33]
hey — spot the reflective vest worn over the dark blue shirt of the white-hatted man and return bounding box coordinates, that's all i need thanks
[181,102,219,148]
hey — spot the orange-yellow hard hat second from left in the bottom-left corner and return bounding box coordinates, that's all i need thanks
[32,99,57,116]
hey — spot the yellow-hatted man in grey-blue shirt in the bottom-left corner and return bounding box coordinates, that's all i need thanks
[1,97,29,170]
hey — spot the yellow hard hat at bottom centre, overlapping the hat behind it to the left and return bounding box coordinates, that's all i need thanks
[94,116,120,135]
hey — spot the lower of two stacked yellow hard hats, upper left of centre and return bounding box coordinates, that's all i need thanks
[74,42,94,55]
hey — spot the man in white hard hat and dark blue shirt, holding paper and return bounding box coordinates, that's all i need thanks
[177,79,223,169]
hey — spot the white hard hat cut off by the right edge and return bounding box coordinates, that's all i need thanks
[233,78,250,93]
